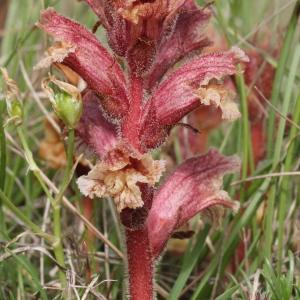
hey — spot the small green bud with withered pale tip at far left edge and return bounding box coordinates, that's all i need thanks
[1,68,23,126]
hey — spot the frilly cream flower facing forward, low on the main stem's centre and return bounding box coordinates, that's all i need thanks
[77,148,165,212]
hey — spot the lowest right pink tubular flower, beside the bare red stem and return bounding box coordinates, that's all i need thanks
[147,150,240,257]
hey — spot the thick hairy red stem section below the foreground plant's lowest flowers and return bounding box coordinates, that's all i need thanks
[126,229,154,300]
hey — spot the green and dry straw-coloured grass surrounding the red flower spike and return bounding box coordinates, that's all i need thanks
[0,0,300,300]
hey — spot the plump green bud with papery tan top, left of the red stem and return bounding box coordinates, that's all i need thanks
[42,76,82,128]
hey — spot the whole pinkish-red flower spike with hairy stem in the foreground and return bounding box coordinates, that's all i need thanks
[38,0,247,299]
